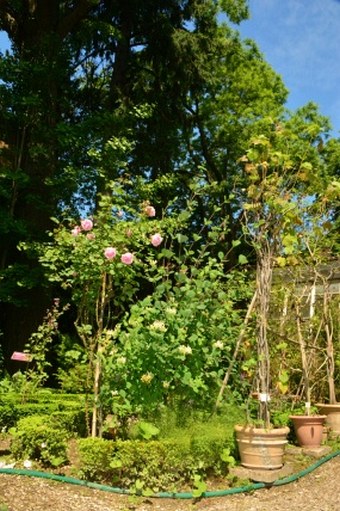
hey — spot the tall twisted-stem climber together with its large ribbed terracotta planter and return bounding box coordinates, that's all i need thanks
[235,134,297,469]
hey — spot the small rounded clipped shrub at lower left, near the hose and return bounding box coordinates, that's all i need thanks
[11,415,69,467]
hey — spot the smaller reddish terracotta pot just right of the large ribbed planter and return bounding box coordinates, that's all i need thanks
[290,415,326,448]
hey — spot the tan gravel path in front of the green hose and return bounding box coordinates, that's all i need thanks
[0,456,340,511]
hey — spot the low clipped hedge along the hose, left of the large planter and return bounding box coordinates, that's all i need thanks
[78,438,231,492]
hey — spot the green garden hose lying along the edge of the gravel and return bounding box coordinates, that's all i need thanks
[0,450,340,499]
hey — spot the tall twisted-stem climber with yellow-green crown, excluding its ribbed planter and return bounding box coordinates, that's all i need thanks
[228,119,328,465]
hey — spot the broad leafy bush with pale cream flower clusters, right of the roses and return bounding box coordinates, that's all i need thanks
[102,266,248,413]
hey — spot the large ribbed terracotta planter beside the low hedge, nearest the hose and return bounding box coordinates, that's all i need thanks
[235,425,289,470]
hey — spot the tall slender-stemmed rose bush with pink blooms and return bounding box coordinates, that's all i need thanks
[33,183,181,435]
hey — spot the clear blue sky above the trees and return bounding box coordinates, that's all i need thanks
[0,0,340,136]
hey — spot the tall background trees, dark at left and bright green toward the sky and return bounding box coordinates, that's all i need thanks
[0,0,340,372]
